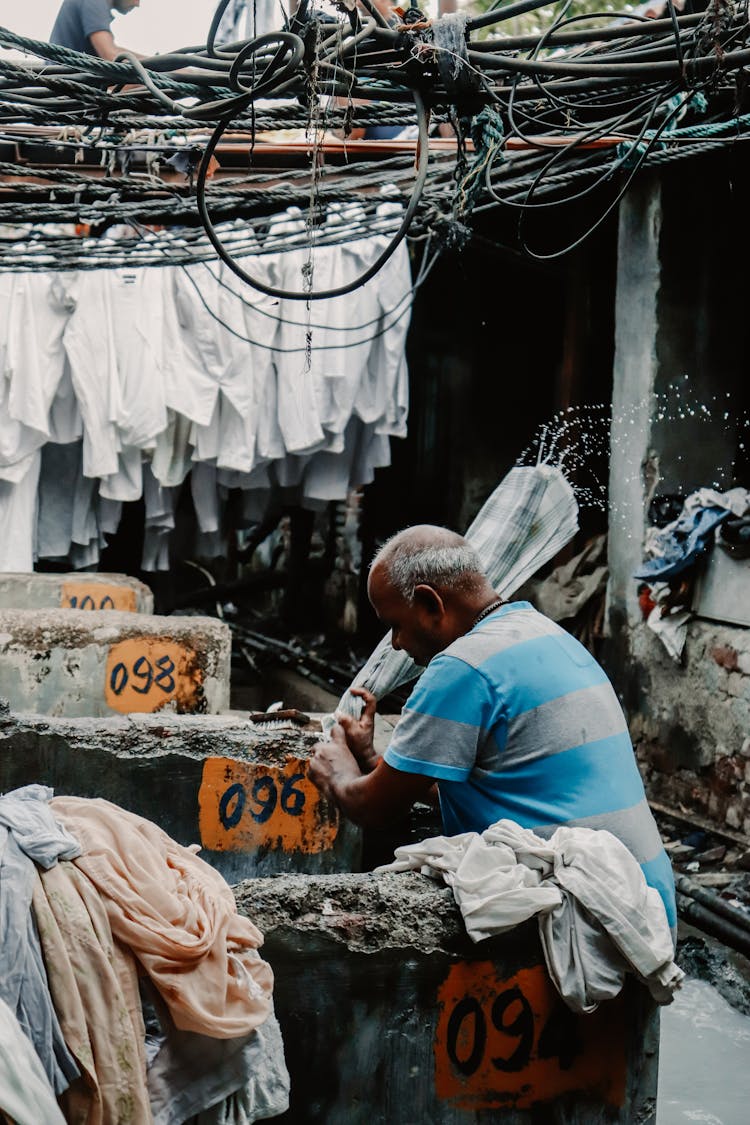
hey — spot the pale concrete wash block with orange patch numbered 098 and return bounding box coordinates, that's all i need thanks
[0,610,231,717]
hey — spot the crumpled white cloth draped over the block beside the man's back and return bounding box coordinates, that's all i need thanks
[377,819,685,1011]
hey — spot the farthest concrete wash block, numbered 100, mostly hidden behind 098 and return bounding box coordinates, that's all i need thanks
[0,570,154,613]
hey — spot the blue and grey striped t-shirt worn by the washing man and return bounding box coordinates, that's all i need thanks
[385,602,677,927]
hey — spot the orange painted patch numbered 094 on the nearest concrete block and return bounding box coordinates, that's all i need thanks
[434,961,626,1109]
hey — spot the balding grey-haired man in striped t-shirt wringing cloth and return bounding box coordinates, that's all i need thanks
[309,524,677,927]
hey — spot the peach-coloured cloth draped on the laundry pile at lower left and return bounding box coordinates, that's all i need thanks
[51,797,273,1040]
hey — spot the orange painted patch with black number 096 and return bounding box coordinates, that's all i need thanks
[198,757,338,854]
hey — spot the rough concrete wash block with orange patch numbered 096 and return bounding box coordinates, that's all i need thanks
[0,706,359,883]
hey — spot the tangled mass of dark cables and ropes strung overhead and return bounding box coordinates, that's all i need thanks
[0,0,750,279]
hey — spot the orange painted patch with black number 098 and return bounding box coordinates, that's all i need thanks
[105,637,202,714]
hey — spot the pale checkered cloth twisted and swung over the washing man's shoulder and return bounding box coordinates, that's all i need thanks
[323,465,578,731]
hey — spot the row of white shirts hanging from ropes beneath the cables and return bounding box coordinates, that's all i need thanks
[0,199,413,570]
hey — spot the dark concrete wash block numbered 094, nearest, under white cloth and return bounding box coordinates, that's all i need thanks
[234,873,659,1125]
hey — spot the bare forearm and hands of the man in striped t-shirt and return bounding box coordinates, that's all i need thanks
[309,726,434,828]
